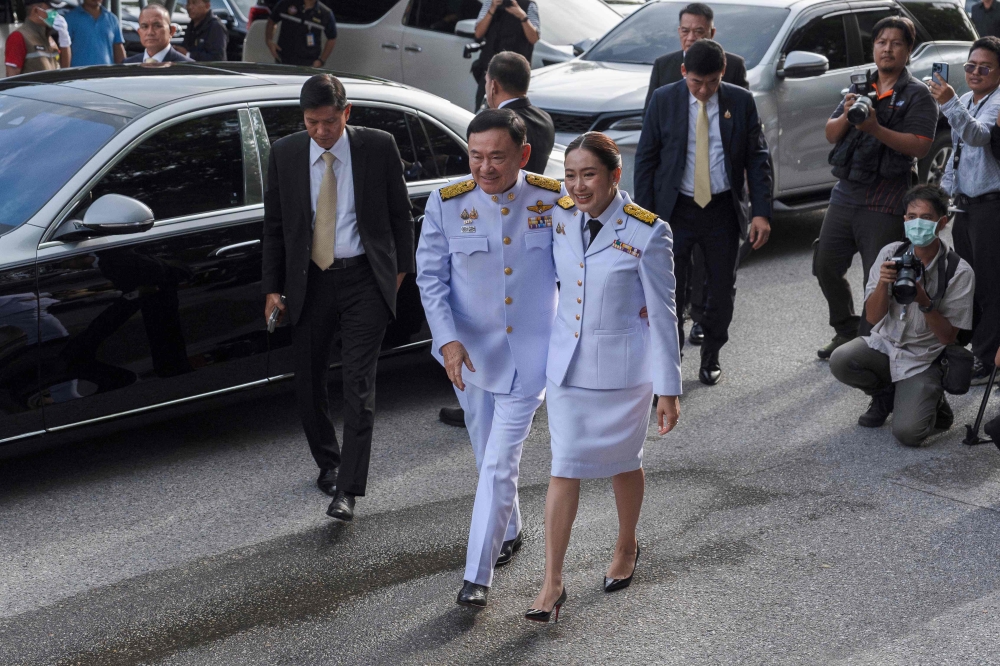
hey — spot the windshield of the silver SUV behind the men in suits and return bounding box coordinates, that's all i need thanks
[584,2,788,69]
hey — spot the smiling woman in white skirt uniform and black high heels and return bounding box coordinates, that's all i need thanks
[525,132,681,622]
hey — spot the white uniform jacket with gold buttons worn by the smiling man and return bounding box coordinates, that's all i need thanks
[417,171,564,394]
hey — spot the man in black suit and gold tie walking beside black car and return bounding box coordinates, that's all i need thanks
[262,74,415,520]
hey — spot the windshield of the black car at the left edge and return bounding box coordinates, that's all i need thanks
[0,95,128,235]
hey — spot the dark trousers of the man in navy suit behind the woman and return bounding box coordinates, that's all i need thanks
[670,191,740,356]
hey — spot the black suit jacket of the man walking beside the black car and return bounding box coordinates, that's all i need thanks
[261,127,416,324]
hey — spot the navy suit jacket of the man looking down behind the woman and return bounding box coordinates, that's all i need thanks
[634,81,771,238]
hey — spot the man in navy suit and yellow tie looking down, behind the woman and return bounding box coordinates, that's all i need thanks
[635,39,771,385]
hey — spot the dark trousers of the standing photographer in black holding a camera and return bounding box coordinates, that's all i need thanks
[813,204,905,338]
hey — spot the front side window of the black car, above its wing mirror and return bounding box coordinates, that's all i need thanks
[91,111,246,220]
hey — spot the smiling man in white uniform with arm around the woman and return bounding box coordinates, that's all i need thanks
[417,109,560,607]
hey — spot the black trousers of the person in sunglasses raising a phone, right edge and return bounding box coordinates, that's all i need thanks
[952,201,1000,366]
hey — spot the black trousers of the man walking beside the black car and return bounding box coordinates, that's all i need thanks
[292,261,390,495]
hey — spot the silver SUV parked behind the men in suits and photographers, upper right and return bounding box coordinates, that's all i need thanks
[529,0,976,212]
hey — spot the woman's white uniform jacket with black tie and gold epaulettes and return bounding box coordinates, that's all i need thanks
[547,192,681,395]
